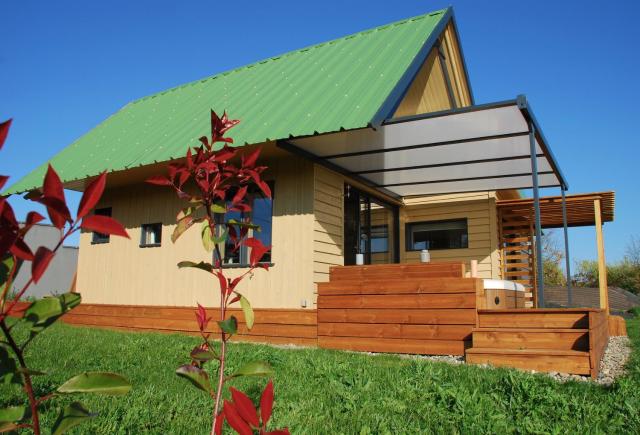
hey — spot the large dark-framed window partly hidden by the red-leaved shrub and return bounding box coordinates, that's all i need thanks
[222,182,274,266]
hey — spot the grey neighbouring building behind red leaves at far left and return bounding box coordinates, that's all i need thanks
[13,224,78,298]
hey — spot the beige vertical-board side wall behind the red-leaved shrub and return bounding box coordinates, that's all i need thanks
[77,156,315,308]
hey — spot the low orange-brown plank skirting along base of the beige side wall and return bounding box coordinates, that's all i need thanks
[63,304,317,346]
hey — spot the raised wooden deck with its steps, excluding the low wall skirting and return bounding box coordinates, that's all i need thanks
[318,263,609,377]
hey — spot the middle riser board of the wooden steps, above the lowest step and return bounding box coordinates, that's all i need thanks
[473,331,589,351]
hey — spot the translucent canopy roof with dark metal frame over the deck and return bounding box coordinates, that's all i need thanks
[279,96,568,197]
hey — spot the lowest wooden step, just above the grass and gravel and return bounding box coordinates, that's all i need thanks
[466,347,591,375]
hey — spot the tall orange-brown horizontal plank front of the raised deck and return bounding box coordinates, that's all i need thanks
[318,263,482,355]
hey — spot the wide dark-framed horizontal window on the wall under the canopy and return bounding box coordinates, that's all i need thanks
[406,219,469,251]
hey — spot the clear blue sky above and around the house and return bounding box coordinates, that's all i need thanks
[0,0,640,260]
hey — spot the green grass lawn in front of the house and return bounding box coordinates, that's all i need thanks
[0,320,640,434]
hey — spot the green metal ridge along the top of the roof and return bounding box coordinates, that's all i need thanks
[123,8,449,109]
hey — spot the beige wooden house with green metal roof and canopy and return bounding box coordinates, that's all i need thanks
[6,8,613,372]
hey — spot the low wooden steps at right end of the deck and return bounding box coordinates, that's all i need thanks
[466,309,608,377]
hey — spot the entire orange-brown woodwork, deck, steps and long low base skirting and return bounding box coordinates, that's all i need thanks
[11,263,624,376]
